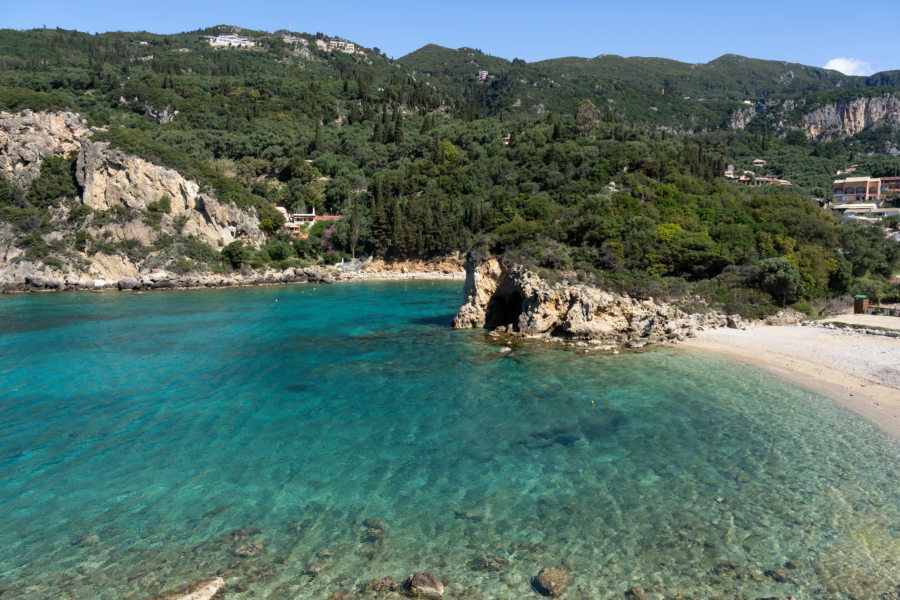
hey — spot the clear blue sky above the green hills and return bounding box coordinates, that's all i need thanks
[7,0,900,71]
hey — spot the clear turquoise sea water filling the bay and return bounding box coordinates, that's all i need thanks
[0,282,900,600]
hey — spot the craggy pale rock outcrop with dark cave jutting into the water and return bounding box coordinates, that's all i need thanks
[453,258,745,348]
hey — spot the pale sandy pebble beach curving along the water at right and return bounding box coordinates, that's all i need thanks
[679,325,900,441]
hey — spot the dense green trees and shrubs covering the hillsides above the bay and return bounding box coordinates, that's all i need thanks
[0,28,900,314]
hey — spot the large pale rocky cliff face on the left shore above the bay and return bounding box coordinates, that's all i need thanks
[0,110,265,283]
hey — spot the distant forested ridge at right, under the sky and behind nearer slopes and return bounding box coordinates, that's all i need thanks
[399,44,900,131]
